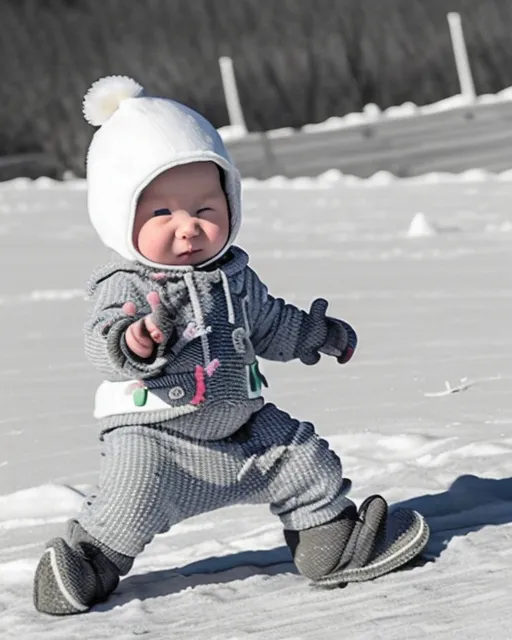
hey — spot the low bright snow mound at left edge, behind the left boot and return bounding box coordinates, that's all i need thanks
[0,484,83,523]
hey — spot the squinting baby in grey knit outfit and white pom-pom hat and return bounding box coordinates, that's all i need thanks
[34,76,429,615]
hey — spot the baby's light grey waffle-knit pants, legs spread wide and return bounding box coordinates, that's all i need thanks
[78,404,351,557]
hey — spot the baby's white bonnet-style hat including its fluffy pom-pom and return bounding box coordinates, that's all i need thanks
[83,76,241,268]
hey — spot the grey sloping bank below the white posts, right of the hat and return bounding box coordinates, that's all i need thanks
[228,101,512,179]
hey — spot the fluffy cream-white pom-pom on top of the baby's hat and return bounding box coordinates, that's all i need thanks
[83,76,144,127]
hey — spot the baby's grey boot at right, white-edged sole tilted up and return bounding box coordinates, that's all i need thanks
[285,496,429,587]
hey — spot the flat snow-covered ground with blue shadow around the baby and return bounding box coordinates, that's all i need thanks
[0,179,512,640]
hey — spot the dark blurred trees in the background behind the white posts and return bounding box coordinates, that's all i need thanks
[0,0,512,175]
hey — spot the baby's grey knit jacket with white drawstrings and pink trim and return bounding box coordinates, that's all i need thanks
[85,247,348,440]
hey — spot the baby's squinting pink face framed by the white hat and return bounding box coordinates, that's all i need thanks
[133,162,229,265]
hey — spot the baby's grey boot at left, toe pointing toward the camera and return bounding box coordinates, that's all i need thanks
[33,521,133,615]
